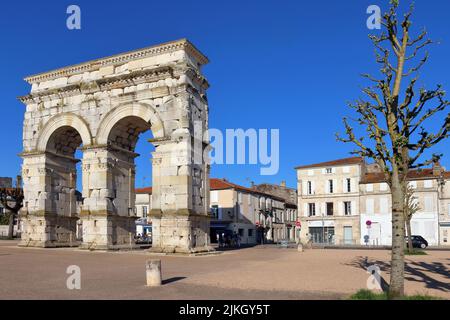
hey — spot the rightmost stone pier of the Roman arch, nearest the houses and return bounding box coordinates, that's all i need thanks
[150,136,211,253]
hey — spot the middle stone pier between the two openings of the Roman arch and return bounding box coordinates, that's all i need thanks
[81,146,136,250]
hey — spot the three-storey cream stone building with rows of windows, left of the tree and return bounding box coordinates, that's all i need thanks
[296,158,363,245]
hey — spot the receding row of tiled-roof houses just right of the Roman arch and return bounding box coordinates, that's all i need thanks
[210,178,297,244]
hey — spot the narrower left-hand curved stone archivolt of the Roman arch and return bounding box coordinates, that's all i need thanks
[36,113,92,152]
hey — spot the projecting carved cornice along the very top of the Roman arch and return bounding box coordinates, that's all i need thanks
[25,39,209,84]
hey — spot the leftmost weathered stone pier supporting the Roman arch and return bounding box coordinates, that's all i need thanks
[19,152,78,247]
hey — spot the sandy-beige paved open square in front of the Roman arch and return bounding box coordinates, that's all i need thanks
[0,241,450,299]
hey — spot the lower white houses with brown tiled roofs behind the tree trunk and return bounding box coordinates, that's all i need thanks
[360,166,450,246]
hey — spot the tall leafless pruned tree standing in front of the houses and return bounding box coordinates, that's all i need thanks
[337,1,450,299]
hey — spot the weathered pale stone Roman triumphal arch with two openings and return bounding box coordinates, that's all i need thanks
[20,40,210,253]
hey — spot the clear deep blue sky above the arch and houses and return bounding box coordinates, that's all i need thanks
[0,0,450,187]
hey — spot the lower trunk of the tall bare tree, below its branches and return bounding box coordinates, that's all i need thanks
[389,174,405,299]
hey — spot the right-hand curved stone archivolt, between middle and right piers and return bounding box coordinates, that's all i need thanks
[95,102,165,145]
